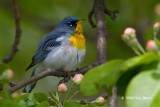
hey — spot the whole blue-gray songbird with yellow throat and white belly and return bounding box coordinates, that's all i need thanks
[23,16,85,93]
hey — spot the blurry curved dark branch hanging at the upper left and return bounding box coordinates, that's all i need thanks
[3,0,22,63]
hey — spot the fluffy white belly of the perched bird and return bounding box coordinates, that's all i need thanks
[43,46,85,71]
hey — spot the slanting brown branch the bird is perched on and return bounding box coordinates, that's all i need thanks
[7,62,99,93]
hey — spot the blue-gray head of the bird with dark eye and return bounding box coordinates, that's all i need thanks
[54,16,80,34]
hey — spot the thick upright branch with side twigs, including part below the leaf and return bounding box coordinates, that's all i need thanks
[88,0,119,107]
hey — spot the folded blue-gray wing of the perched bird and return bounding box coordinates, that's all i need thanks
[26,33,61,71]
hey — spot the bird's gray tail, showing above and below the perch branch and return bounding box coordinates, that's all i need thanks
[22,67,41,93]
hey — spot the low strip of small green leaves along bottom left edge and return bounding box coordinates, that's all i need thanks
[0,78,107,107]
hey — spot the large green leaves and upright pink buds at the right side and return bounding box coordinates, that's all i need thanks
[81,22,160,107]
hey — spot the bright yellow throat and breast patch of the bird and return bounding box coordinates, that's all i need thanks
[69,21,86,50]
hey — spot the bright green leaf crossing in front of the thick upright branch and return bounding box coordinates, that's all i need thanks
[80,60,124,95]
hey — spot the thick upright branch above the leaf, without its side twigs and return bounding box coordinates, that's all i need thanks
[93,0,107,64]
